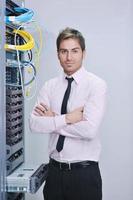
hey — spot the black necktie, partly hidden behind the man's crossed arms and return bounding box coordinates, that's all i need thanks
[56,77,74,152]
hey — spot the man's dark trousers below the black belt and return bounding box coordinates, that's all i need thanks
[43,163,102,200]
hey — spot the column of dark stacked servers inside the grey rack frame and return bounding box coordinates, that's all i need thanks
[5,0,24,200]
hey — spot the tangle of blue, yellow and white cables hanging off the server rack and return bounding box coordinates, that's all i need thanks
[5,7,42,99]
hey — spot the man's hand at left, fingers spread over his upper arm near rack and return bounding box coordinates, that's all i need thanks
[34,103,55,117]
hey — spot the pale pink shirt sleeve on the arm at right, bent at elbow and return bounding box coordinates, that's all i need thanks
[56,81,107,140]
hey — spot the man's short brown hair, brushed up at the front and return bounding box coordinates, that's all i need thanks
[56,27,85,51]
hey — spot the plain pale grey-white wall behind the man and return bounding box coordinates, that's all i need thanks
[25,0,133,200]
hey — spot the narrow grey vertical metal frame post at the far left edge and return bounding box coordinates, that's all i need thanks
[0,0,6,200]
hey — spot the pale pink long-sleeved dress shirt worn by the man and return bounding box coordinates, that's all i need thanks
[30,67,107,162]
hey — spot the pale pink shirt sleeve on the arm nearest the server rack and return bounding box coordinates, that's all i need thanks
[29,83,66,133]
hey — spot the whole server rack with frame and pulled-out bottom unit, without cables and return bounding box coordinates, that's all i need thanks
[0,0,48,200]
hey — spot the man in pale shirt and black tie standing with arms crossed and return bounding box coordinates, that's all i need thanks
[30,28,106,200]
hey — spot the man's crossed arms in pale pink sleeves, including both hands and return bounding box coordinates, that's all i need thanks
[30,79,106,139]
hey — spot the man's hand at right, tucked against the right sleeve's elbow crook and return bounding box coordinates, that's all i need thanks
[66,107,83,124]
